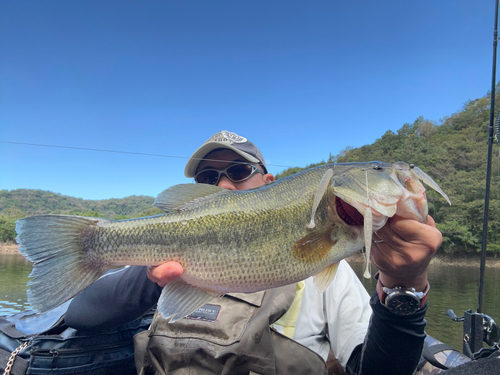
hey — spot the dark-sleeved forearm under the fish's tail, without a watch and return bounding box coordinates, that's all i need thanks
[65,267,161,330]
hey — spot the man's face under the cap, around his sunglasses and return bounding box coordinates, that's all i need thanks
[196,150,274,190]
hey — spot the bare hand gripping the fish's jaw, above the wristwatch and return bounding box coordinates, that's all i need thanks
[371,216,442,291]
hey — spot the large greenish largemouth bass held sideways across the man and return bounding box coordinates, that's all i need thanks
[16,162,449,322]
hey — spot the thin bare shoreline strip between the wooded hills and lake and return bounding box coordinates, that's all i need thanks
[0,242,500,268]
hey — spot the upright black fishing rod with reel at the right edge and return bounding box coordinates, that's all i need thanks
[447,0,500,359]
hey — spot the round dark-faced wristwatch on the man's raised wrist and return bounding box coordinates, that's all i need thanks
[375,272,430,315]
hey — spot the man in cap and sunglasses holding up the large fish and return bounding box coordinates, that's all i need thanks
[66,131,441,375]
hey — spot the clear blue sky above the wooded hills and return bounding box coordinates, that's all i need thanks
[0,0,495,199]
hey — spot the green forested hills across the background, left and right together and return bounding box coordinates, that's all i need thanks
[0,86,500,254]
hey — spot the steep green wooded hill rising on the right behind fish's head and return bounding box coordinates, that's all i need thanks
[277,86,500,253]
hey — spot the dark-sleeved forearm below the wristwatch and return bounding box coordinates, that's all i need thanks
[346,293,427,375]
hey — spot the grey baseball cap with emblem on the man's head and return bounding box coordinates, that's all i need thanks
[184,130,267,177]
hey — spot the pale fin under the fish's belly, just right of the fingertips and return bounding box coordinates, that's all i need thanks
[158,279,221,323]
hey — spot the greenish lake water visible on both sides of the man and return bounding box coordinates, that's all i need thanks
[0,254,500,351]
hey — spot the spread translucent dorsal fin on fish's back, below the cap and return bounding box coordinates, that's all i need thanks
[153,184,229,211]
